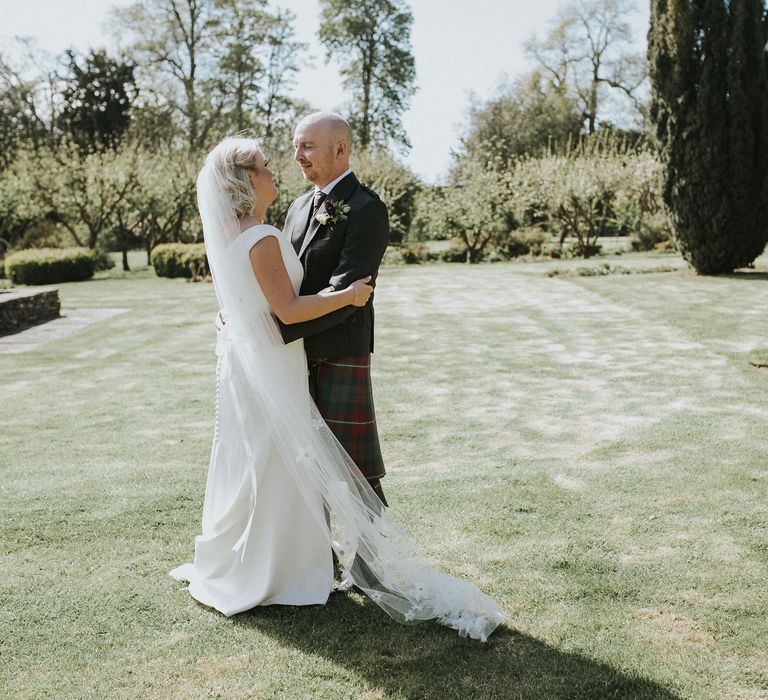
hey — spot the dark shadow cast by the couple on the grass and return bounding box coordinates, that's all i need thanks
[232,594,679,700]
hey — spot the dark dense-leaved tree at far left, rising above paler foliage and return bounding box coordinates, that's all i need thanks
[58,50,136,151]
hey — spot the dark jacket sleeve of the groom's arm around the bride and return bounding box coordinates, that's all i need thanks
[278,199,389,343]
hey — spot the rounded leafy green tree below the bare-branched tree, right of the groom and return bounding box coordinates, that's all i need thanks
[462,70,582,163]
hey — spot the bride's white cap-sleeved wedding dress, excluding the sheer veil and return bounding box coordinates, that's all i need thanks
[171,226,333,615]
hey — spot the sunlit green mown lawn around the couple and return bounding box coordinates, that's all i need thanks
[0,255,768,700]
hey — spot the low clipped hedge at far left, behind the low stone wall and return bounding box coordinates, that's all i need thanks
[5,248,96,284]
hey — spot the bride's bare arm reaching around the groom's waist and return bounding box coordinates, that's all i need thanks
[250,236,372,323]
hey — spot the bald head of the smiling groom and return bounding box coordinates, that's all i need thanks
[293,112,352,188]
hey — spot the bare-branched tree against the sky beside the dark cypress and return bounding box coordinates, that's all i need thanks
[526,0,647,134]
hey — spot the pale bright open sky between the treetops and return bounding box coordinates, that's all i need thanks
[0,0,648,183]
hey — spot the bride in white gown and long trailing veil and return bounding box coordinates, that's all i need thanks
[171,138,503,641]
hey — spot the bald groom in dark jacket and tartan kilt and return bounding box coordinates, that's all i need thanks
[280,112,389,506]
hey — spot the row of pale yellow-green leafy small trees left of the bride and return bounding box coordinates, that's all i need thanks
[0,142,200,267]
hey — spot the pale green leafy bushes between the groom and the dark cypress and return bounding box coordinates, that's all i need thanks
[408,134,670,262]
